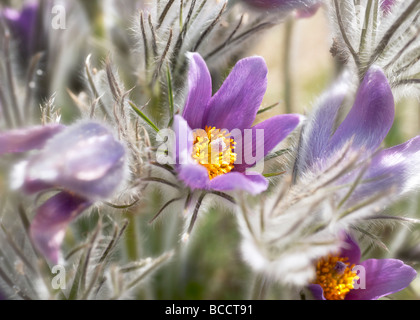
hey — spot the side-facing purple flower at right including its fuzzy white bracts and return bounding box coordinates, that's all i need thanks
[238,67,420,286]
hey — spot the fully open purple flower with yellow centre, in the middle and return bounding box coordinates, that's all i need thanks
[174,53,300,194]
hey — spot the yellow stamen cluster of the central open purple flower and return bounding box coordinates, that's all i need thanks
[192,126,236,180]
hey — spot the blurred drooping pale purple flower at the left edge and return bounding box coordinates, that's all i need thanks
[0,122,125,263]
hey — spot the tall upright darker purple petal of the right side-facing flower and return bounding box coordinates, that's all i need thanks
[324,67,394,161]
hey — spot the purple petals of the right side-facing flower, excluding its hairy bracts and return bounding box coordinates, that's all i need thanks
[296,66,420,205]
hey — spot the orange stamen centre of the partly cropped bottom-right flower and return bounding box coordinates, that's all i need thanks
[314,255,359,300]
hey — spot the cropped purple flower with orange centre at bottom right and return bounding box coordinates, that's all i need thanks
[309,235,417,300]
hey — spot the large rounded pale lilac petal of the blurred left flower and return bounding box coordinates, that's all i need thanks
[24,122,125,200]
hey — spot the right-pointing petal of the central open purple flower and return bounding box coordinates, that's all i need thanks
[234,114,301,172]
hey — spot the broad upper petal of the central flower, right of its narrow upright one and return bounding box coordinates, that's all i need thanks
[203,57,267,131]
